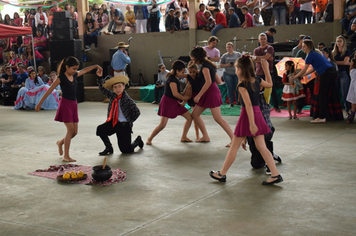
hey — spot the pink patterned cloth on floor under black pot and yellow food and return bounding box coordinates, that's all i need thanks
[28,164,126,186]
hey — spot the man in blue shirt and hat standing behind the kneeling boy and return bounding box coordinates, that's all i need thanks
[111,42,131,75]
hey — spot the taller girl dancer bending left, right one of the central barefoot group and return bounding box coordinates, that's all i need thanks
[190,47,234,147]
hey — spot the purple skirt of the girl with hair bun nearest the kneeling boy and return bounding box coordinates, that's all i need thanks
[157,95,188,119]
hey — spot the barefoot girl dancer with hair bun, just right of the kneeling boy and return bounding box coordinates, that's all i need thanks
[146,61,192,145]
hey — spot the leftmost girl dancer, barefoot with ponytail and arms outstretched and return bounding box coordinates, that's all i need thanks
[35,57,103,162]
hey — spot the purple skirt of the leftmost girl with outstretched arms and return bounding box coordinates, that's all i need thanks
[54,97,79,123]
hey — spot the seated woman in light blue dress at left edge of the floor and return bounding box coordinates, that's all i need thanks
[13,67,59,110]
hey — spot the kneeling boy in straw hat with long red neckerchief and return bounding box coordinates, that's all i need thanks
[96,75,143,155]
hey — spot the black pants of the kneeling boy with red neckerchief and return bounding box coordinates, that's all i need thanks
[96,121,135,153]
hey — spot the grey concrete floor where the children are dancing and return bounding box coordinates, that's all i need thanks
[0,102,356,236]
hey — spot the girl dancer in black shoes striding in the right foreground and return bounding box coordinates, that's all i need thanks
[209,56,283,185]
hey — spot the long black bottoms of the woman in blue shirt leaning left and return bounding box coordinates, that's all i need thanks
[319,67,337,119]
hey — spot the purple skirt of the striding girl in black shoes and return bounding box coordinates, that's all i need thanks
[234,106,271,137]
